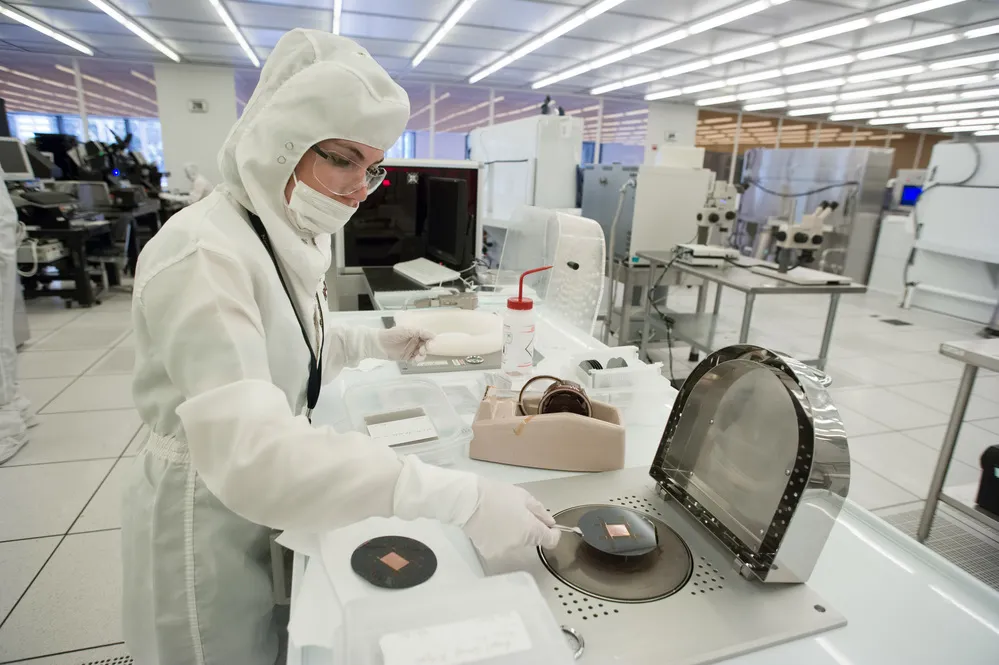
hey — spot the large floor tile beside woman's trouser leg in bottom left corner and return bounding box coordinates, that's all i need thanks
[0,531,122,661]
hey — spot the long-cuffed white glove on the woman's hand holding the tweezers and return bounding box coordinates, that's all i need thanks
[393,455,562,559]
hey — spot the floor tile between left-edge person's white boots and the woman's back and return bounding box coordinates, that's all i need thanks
[4,409,142,467]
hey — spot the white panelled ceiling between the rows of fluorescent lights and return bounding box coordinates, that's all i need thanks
[0,0,999,136]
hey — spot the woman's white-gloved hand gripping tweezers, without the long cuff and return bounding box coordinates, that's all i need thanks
[464,478,562,559]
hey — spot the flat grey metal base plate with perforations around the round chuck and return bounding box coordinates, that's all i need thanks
[487,468,846,665]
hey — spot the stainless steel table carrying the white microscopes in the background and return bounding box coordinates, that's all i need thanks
[638,252,867,369]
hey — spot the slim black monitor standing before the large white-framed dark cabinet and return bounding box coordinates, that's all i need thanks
[424,177,475,270]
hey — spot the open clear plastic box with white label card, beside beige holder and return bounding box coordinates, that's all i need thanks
[343,378,472,466]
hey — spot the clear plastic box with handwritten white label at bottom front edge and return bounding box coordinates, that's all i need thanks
[337,572,574,665]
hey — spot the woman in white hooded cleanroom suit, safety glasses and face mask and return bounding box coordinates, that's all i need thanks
[122,29,558,665]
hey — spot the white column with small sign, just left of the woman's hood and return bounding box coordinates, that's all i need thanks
[155,65,236,185]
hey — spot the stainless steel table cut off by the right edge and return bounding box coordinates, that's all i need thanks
[916,339,999,541]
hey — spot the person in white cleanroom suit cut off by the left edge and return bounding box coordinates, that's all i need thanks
[0,178,35,466]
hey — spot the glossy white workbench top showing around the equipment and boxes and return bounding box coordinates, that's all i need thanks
[288,313,999,665]
